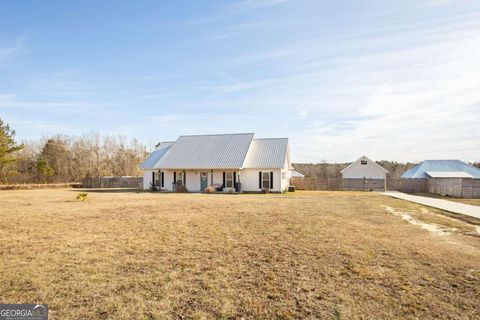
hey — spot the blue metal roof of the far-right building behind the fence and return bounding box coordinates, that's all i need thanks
[402,160,480,179]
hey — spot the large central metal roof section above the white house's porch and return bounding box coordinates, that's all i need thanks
[155,133,254,169]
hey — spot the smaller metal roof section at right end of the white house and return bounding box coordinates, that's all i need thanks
[243,138,288,169]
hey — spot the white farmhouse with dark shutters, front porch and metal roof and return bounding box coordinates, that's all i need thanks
[141,133,293,192]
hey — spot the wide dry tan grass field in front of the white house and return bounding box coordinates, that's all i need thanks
[0,189,480,319]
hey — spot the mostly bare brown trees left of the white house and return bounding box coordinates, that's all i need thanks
[0,119,148,183]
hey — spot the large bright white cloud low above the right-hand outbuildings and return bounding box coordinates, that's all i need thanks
[294,32,480,161]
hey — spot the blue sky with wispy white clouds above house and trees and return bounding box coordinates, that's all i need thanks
[0,0,480,163]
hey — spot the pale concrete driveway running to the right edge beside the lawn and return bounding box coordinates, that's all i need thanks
[382,191,480,219]
